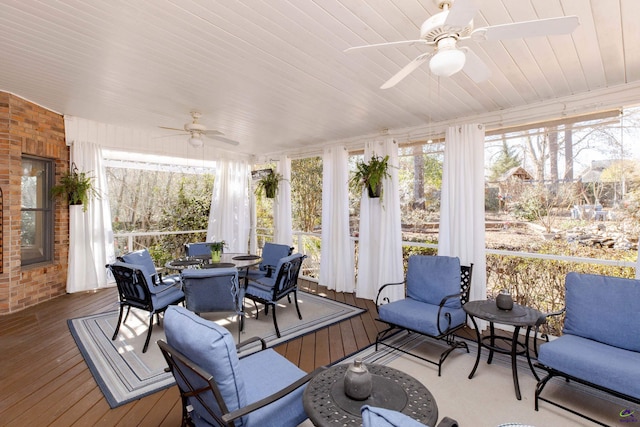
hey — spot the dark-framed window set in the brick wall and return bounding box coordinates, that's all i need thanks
[20,156,54,266]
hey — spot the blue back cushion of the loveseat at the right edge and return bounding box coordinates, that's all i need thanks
[563,273,640,351]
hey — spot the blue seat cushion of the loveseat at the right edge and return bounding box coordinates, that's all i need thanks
[538,334,640,399]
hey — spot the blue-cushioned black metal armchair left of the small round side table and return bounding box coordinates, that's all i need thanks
[376,255,473,376]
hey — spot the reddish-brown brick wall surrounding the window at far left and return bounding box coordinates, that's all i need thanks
[0,92,69,314]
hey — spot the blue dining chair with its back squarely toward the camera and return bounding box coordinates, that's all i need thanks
[182,268,244,336]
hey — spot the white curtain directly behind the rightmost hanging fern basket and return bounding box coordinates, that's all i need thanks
[356,139,404,301]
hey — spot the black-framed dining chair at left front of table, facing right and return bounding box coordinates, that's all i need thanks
[107,261,184,353]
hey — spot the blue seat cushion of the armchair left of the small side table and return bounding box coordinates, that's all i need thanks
[378,297,466,337]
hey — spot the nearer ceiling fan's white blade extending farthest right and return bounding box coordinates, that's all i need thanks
[470,16,580,41]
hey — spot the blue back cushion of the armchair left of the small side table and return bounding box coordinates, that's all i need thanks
[407,255,461,308]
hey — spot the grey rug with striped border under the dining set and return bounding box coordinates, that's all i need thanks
[68,292,365,408]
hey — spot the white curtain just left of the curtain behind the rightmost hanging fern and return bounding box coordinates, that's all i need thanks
[320,146,355,292]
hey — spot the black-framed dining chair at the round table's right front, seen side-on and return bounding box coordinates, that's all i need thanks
[243,253,307,338]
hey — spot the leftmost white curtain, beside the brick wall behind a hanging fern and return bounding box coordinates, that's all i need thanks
[65,117,115,293]
